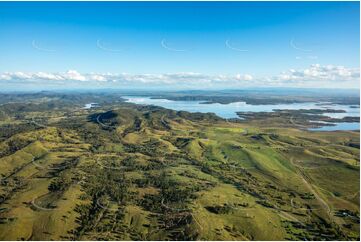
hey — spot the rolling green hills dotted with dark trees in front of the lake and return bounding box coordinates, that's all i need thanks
[0,94,360,240]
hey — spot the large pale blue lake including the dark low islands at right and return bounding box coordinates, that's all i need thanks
[122,96,360,131]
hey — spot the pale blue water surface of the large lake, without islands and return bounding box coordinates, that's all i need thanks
[122,96,360,131]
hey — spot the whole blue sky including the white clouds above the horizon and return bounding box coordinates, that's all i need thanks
[0,2,360,88]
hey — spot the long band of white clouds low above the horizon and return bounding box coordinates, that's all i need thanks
[0,64,360,88]
